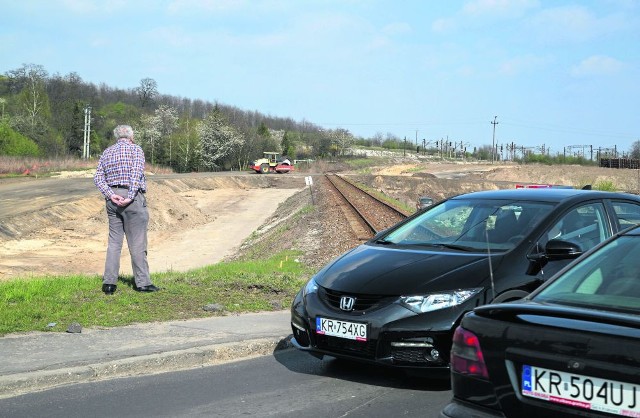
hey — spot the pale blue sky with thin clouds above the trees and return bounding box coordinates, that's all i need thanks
[0,0,640,155]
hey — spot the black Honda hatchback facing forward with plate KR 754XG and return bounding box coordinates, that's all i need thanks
[291,188,640,377]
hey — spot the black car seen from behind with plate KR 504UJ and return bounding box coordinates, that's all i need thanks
[440,227,640,418]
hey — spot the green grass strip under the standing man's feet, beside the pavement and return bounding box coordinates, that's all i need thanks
[0,252,310,336]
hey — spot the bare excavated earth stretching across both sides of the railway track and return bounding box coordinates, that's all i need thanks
[0,158,640,280]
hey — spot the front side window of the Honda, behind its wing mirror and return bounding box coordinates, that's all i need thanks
[540,203,610,251]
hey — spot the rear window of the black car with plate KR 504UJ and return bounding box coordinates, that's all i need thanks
[533,236,640,315]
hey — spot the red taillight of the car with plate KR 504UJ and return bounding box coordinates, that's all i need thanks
[451,327,489,379]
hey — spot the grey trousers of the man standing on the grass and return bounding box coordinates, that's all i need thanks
[102,189,151,287]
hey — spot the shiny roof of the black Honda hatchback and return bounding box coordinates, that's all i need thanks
[454,188,640,202]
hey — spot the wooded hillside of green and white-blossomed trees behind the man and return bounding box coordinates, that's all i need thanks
[0,64,355,172]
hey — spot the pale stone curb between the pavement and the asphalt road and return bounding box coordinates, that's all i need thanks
[0,335,293,399]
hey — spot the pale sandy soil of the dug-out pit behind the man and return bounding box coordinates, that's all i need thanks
[0,177,299,280]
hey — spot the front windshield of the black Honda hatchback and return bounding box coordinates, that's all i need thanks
[378,199,553,251]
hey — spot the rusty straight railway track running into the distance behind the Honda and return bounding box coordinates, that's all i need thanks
[325,174,410,240]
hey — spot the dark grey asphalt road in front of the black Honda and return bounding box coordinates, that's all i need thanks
[0,349,451,418]
